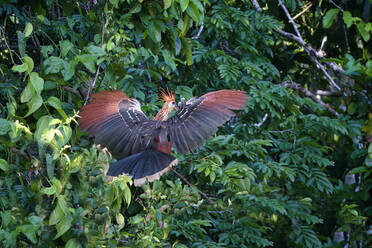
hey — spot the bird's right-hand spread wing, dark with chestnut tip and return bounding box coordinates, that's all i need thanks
[164,90,248,153]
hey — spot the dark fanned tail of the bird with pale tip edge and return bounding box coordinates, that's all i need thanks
[107,150,178,186]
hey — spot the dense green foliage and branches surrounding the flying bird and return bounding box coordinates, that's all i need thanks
[0,0,372,248]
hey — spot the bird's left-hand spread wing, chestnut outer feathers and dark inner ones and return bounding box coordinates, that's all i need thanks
[79,91,154,159]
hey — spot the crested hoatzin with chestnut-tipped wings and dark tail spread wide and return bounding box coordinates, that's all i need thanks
[79,89,248,186]
